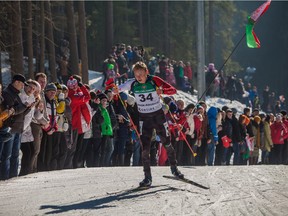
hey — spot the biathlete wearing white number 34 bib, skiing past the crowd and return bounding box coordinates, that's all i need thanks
[115,62,184,187]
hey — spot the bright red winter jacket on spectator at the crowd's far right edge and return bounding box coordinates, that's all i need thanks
[270,122,288,145]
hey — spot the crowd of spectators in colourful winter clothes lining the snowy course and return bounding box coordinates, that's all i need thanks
[0,44,288,180]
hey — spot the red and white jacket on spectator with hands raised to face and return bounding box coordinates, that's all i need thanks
[68,86,91,134]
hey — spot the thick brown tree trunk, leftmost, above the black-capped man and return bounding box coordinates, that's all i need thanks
[11,1,24,74]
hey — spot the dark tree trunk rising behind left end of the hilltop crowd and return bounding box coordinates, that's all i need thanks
[105,1,114,56]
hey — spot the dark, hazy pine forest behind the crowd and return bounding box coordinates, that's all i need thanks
[0,1,288,94]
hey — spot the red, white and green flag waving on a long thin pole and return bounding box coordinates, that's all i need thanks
[246,0,271,48]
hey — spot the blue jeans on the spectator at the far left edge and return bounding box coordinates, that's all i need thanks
[0,133,21,180]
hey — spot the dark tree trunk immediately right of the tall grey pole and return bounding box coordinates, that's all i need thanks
[208,1,215,62]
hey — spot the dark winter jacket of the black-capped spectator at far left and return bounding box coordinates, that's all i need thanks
[2,84,27,133]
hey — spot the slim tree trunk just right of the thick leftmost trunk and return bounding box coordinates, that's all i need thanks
[27,1,34,79]
